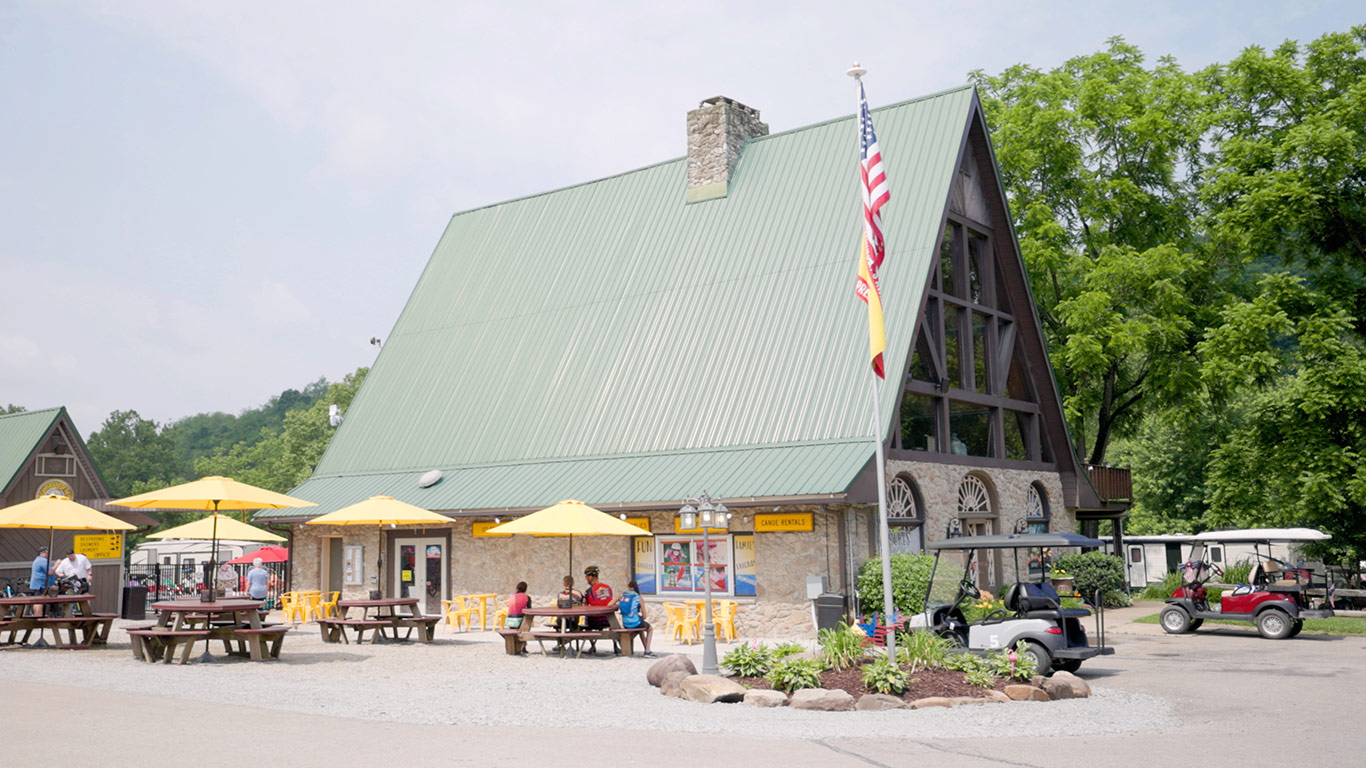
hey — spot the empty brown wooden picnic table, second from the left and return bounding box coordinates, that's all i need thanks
[128,599,290,664]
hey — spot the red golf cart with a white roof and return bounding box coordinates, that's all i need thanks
[1161,527,1333,640]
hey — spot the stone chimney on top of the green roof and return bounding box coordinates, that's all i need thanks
[687,96,768,202]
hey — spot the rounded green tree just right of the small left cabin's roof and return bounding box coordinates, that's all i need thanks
[86,410,183,499]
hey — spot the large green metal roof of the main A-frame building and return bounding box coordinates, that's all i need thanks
[277,87,974,517]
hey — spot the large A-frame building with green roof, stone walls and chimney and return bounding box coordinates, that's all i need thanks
[261,87,1112,634]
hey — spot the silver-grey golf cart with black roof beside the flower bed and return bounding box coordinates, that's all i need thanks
[906,533,1115,675]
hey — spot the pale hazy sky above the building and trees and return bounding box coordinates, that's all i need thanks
[0,0,1363,435]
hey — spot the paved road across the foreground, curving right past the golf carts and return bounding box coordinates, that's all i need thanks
[0,611,1366,768]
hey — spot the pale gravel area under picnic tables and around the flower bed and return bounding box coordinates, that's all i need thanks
[0,622,1173,739]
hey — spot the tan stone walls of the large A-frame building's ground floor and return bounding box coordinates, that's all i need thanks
[291,461,1075,637]
